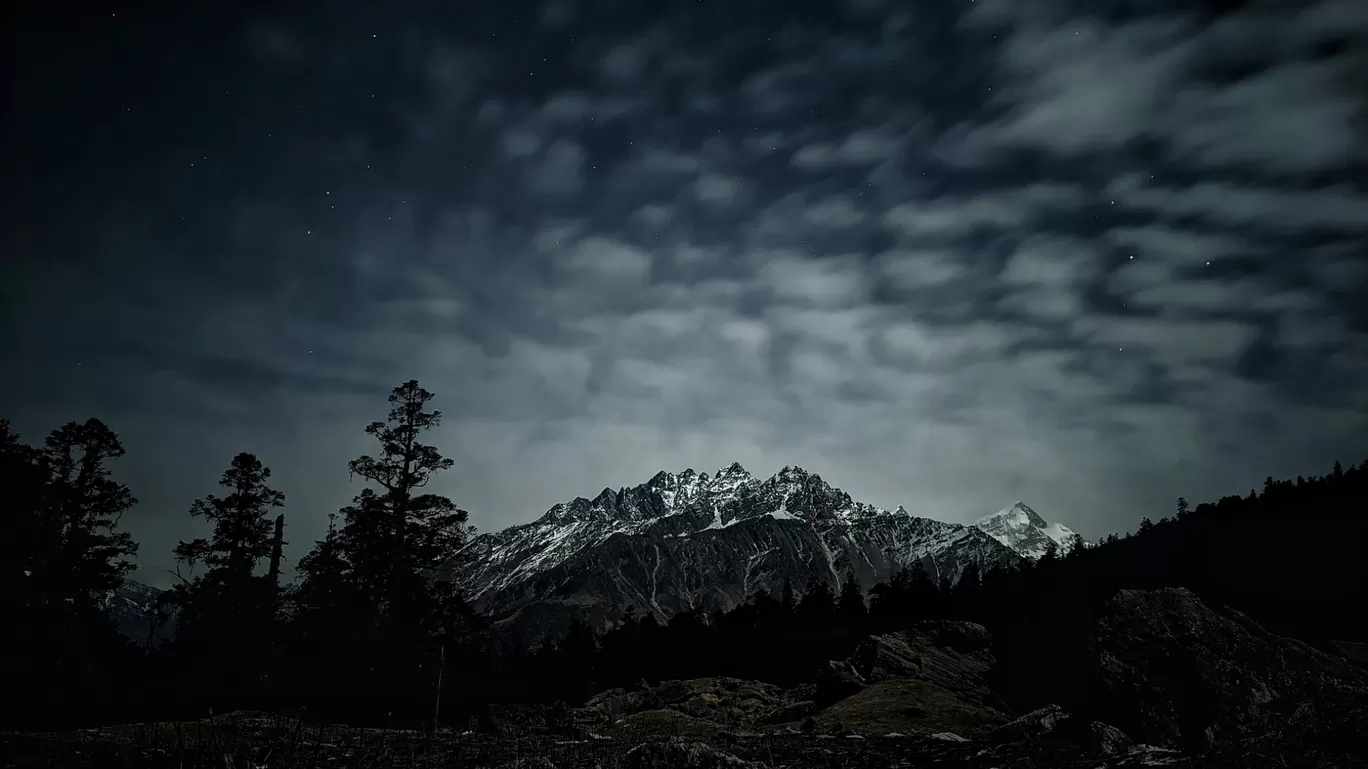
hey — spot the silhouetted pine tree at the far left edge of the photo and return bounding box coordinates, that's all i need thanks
[10,419,137,725]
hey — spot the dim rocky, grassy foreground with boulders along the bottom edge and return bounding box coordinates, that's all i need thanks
[3,590,1368,769]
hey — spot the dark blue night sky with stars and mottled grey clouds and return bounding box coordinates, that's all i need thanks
[0,0,1368,583]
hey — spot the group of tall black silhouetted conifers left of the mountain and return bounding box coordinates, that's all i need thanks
[9,380,490,725]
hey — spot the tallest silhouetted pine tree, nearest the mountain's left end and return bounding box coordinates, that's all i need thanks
[283,380,481,717]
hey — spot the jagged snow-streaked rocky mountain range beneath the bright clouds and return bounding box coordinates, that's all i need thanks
[450,464,1071,643]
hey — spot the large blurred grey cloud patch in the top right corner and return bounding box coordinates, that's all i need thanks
[944,0,1365,175]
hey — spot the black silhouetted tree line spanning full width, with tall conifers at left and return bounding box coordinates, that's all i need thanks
[0,380,1368,728]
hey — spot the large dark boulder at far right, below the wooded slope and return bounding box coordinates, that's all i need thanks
[1097,588,1368,751]
